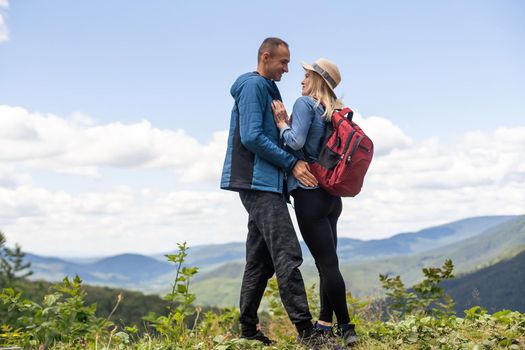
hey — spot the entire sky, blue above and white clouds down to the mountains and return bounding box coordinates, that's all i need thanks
[0,0,525,257]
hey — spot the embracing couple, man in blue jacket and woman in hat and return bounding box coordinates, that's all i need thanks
[221,38,357,349]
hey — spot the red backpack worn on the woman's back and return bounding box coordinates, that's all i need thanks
[310,107,374,197]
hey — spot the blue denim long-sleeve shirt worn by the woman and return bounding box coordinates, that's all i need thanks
[280,96,325,191]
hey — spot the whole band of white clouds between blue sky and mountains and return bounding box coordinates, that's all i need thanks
[0,106,525,255]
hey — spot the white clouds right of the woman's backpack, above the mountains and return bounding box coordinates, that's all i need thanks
[340,127,525,239]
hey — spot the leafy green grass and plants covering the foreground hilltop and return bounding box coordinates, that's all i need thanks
[0,239,525,350]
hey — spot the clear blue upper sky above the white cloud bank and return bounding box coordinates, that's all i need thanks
[4,1,525,140]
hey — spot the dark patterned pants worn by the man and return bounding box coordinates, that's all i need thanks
[239,191,312,325]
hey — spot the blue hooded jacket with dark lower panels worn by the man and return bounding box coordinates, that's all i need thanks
[221,72,297,193]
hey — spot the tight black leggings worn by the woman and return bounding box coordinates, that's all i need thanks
[292,188,350,324]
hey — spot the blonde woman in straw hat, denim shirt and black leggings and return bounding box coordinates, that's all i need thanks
[272,58,357,345]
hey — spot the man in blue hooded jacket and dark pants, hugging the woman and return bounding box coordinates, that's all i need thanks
[221,38,334,348]
